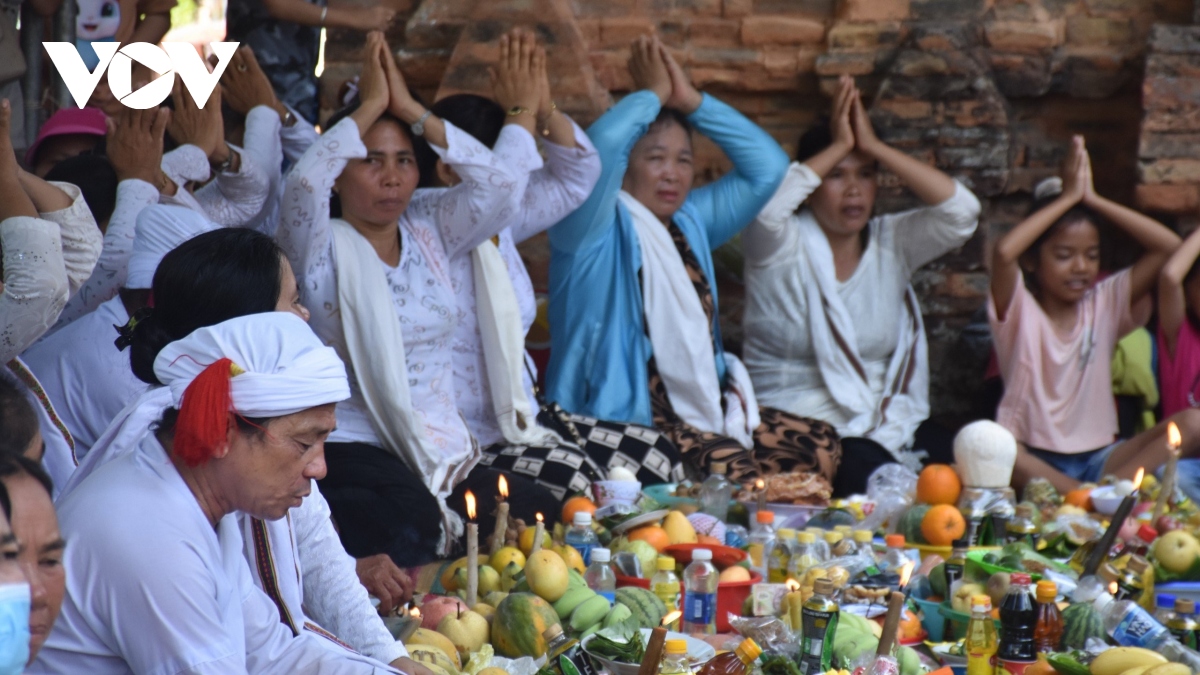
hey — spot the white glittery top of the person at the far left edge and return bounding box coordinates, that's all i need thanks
[0,183,103,363]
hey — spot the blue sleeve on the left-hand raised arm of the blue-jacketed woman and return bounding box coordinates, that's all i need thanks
[550,90,662,252]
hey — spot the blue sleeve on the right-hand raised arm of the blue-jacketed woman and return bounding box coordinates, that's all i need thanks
[688,94,788,249]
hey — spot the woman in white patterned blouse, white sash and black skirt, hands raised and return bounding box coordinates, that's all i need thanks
[276,32,549,566]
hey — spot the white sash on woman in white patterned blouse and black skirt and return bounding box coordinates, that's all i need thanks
[330,219,480,554]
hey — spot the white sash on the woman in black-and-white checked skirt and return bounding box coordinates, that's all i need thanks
[470,240,563,447]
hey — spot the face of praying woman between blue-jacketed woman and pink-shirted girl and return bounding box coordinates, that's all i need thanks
[809,150,878,237]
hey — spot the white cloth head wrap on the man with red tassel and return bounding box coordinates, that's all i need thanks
[61,312,350,496]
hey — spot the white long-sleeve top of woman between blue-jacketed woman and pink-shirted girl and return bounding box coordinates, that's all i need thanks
[742,162,979,441]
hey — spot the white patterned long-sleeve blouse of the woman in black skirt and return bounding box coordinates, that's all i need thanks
[276,118,535,456]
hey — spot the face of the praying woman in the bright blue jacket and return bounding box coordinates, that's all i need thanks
[622,121,696,222]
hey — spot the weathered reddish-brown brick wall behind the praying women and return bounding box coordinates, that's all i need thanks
[323,0,1200,420]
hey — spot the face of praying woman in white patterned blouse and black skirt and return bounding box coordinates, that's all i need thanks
[334,119,420,227]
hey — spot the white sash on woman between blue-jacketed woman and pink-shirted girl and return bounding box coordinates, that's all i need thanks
[796,209,929,471]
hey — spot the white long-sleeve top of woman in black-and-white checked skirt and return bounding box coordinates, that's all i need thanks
[450,121,600,446]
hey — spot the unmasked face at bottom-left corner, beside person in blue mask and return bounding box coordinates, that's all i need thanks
[4,473,66,663]
